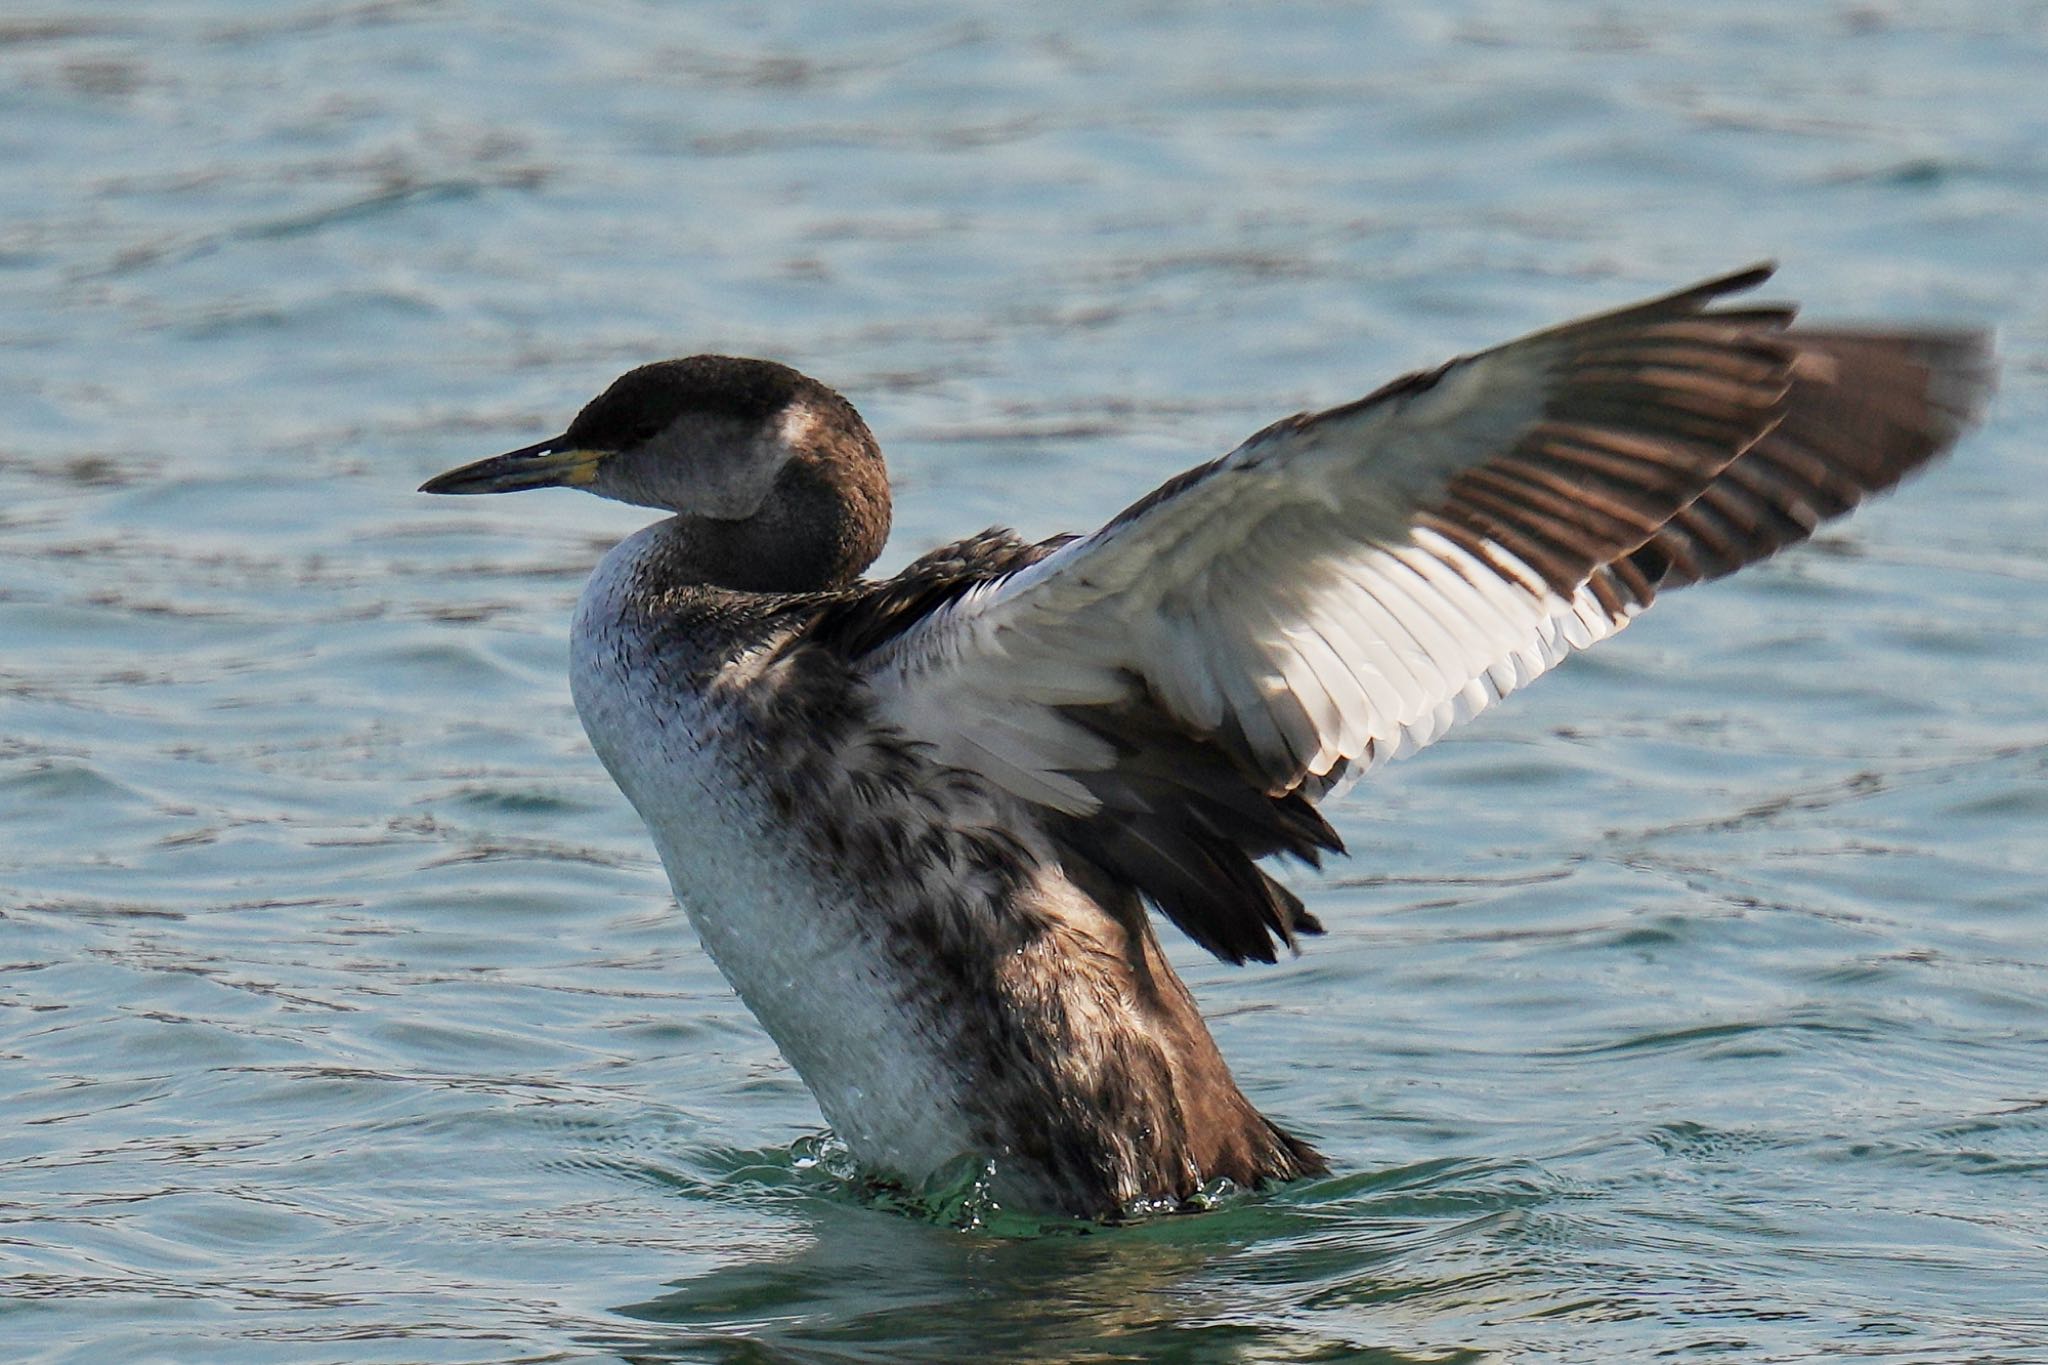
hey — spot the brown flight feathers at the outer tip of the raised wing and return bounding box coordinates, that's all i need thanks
[1434,262,1993,608]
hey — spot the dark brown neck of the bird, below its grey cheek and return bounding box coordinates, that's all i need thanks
[676,454,889,591]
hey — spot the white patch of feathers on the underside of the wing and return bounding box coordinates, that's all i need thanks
[872,501,1632,814]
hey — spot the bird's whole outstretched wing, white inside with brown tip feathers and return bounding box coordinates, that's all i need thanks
[862,266,1989,962]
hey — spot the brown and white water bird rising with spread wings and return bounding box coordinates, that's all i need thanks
[424,266,1991,1218]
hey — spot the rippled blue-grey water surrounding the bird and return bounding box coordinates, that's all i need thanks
[0,0,2048,1365]
